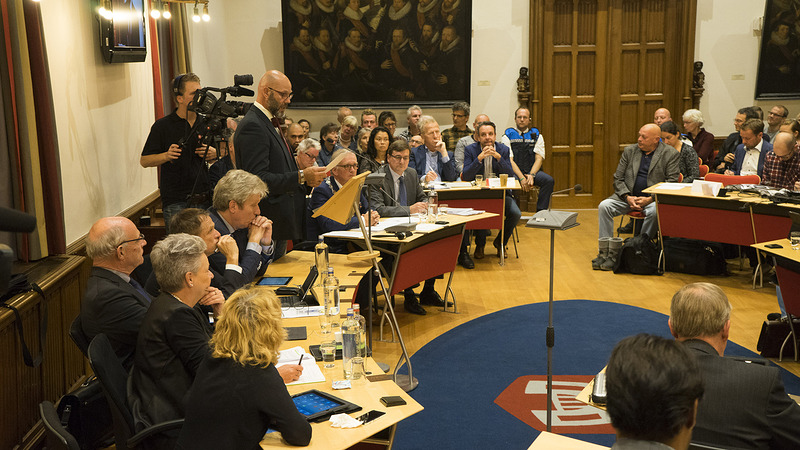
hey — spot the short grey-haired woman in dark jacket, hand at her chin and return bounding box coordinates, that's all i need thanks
[128,233,225,448]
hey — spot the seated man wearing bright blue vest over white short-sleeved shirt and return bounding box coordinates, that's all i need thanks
[500,108,554,211]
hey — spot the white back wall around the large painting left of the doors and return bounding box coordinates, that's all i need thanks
[190,0,529,132]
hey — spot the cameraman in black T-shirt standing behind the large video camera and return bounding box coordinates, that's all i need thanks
[139,72,217,229]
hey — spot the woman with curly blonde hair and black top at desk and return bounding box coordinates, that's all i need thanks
[176,286,311,449]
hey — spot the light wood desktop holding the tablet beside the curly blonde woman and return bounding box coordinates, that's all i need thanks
[261,318,423,450]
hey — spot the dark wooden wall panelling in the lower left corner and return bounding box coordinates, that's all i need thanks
[0,256,89,449]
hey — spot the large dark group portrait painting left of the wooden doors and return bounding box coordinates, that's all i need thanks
[282,0,472,107]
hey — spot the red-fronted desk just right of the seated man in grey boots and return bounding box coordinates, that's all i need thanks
[644,183,797,289]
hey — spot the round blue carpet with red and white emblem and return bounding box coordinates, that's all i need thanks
[394,300,800,449]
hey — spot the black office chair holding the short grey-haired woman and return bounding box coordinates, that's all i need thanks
[89,333,183,450]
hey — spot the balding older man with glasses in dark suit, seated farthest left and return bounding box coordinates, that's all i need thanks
[81,217,152,368]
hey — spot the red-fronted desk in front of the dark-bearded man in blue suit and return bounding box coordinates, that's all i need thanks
[436,177,521,266]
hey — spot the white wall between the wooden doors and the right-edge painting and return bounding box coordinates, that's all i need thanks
[692,0,800,136]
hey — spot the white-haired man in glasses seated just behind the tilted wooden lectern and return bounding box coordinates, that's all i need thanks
[307,148,380,253]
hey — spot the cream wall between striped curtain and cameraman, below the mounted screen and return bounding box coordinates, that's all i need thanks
[40,1,157,243]
